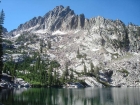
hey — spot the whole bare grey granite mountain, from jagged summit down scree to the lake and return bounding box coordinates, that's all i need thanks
[9,6,140,86]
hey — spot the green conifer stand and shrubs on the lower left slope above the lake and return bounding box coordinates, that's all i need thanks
[3,53,84,86]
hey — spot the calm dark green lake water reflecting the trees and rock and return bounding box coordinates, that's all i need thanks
[0,88,140,105]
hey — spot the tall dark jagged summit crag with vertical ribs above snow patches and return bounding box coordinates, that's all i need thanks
[10,6,85,34]
